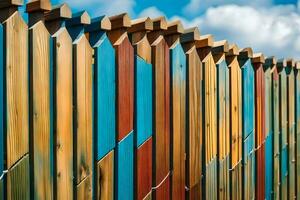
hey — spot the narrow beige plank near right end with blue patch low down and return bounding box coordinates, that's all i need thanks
[278,68,288,199]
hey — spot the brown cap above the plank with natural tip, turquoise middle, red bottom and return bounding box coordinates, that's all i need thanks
[128,17,153,33]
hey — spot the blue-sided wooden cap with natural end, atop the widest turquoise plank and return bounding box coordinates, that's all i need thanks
[85,16,111,32]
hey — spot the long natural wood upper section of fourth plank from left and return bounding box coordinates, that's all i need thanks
[73,35,93,188]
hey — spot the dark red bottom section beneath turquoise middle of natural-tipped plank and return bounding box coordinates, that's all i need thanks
[135,137,152,200]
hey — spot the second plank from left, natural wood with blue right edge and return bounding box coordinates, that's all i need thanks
[29,22,54,199]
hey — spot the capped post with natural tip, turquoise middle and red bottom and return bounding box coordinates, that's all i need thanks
[128,18,153,200]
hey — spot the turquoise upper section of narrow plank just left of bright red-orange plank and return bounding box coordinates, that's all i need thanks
[242,59,255,139]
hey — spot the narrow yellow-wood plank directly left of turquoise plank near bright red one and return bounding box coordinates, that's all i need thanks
[227,57,242,199]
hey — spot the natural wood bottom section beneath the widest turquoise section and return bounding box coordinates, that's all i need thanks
[96,151,114,200]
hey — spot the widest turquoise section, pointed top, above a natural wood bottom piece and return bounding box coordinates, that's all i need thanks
[90,31,116,161]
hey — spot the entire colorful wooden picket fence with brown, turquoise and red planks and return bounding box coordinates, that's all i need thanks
[0,0,300,200]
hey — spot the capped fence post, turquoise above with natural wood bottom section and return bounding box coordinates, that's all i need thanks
[85,16,116,200]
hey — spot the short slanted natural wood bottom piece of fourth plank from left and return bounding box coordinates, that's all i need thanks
[76,175,93,200]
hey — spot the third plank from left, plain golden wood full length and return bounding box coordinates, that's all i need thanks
[53,28,73,199]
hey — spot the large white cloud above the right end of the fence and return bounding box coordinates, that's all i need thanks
[173,5,300,59]
